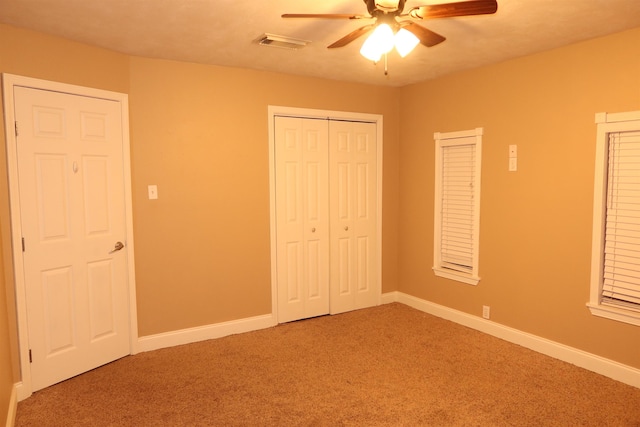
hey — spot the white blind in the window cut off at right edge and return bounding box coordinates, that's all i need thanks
[601,131,640,311]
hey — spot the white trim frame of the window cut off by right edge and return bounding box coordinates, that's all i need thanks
[587,111,640,326]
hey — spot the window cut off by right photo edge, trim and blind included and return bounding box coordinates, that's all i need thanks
[587,111,640,326]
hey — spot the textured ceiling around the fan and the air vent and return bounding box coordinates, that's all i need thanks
[0,0,640,86]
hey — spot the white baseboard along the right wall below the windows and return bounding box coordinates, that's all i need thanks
[382,292,640,388]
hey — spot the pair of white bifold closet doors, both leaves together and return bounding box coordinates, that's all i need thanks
[275,117,380,322]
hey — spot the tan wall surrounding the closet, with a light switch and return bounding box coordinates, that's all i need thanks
[130,58,399,336]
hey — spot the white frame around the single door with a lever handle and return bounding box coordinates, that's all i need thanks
[2,74,138,400]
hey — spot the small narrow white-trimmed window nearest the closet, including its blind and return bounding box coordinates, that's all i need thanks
[433,128,482,285]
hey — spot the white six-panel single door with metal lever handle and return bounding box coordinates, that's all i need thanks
[14,87,130,391]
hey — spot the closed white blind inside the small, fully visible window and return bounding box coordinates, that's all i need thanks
[440,144,476,274]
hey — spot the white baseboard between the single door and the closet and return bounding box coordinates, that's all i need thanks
[137,314,276,352]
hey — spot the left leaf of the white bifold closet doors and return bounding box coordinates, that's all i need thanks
[275,117,329,322]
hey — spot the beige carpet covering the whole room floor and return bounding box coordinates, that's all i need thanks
[16,304,640,426]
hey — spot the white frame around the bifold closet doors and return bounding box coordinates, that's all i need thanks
[268,105,383,324]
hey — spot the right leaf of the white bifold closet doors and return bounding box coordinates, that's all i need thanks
[329,121,379,314]
